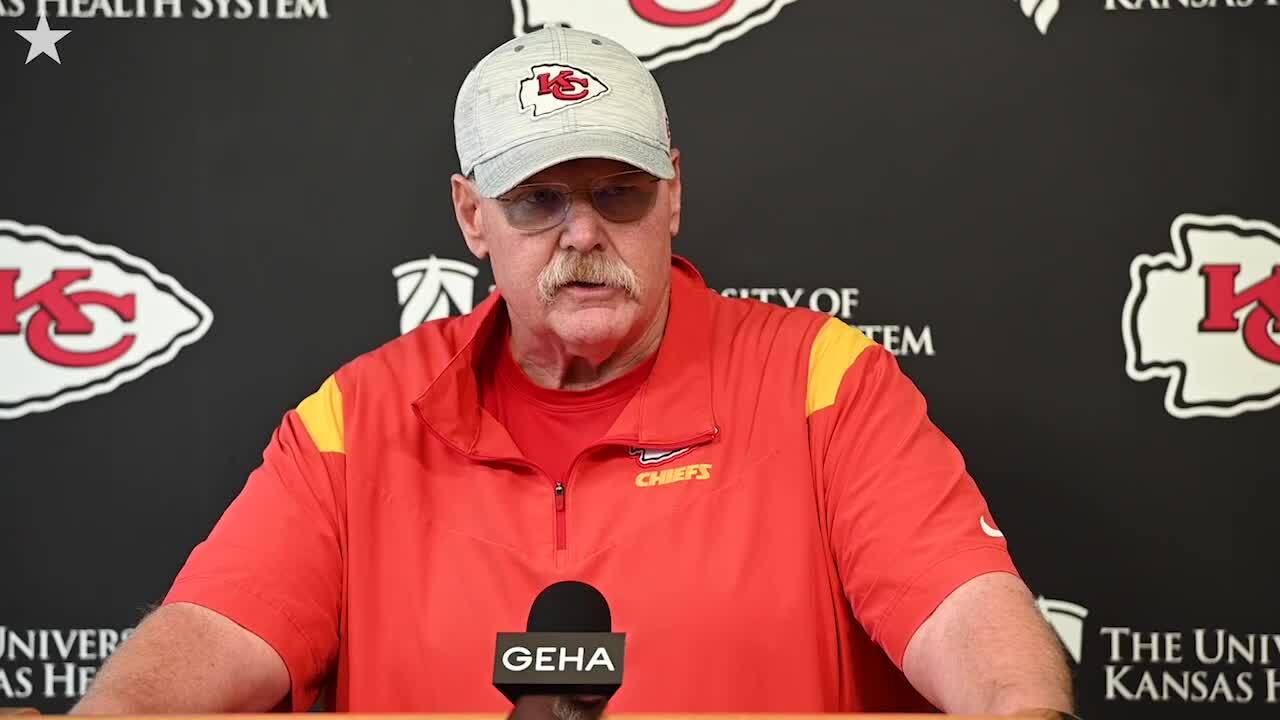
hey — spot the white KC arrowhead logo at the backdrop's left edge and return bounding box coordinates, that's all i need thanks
[0,220,214,419]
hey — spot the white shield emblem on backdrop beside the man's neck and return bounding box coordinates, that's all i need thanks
[392,255,480,334]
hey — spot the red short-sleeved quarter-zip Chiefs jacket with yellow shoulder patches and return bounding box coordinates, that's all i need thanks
[165,252,1016,712]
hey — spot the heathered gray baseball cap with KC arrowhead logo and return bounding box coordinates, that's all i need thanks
[453,26,676,197]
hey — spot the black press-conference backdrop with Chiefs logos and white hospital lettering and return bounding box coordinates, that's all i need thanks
[0,0,1280,719]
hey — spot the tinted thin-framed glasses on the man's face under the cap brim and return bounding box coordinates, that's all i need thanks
[497,170,658,232]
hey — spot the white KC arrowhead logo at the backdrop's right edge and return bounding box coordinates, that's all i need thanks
[1121,214,1280,418]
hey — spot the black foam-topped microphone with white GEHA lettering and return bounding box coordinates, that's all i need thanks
[493,580,626,717]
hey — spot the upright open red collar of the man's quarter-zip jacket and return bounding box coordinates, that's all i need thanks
[412,255,718,457]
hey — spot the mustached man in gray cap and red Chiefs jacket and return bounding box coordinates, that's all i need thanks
[76,27,1071,714]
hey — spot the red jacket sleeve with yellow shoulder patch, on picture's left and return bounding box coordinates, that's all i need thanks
[164,377,346,712]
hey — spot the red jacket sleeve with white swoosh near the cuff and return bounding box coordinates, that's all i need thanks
[806,319,1018,669]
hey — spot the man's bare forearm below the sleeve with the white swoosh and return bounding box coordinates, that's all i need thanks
[902,573,1073,720]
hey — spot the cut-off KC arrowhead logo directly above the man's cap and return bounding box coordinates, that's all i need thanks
[511,0,795,69]
